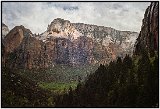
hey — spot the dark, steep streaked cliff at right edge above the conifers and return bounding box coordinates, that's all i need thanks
[135,2,159,54]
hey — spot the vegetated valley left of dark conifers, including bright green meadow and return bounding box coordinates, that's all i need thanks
[2,66,96,107]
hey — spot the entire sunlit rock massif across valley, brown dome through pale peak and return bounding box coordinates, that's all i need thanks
[3,18,138,69]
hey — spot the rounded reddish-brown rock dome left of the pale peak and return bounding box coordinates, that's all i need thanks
[3,26,40,67]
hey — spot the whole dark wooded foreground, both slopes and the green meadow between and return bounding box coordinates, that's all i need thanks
[2,52,159,107]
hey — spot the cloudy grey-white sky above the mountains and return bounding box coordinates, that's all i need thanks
[2,2,150,33]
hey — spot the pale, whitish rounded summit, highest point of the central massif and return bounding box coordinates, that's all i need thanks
[40,18,81,41]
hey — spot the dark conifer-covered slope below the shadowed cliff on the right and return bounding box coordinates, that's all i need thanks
[56,52,159,107]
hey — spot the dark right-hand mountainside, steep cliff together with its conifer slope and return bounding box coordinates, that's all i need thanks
[55,2,159,108]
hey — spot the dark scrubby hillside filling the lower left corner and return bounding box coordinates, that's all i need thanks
[1,68,55,107]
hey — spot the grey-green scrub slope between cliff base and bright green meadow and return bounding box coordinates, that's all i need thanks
[16,65,98,83]
